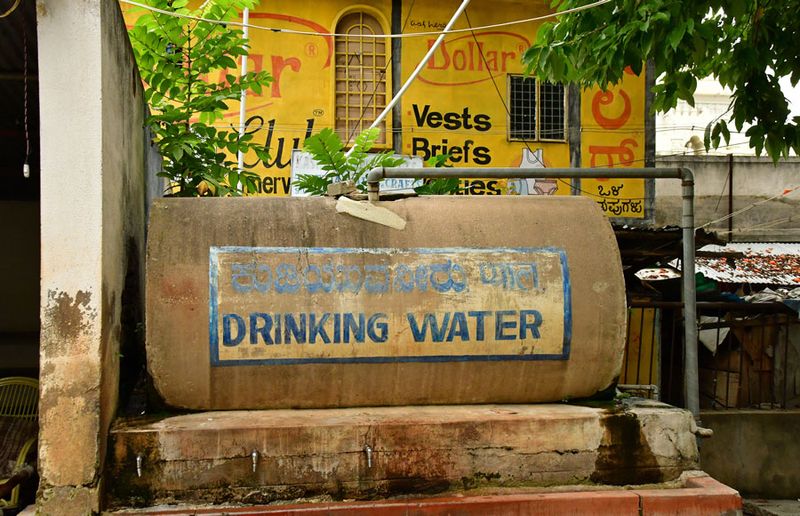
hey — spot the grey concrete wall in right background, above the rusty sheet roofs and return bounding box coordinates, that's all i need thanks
[655,156,800,242]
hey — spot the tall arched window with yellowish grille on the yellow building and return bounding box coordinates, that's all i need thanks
[335,12,387,146]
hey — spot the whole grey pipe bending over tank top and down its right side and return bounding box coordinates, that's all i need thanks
[367,167,700,418]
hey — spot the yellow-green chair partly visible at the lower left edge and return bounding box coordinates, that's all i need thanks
[0,376,39,509]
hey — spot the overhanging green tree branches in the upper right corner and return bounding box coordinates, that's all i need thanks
[523,0,800,161]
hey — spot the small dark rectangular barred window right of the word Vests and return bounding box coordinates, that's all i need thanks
[508,75,567,142]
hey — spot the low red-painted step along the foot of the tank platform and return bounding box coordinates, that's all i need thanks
[109,471,740,516]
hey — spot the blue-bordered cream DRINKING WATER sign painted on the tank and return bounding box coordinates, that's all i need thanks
[209,247,572,366]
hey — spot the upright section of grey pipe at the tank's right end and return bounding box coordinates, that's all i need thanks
[681,168,700,418]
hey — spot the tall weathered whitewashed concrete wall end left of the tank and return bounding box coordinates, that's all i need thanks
[37,0,158,514]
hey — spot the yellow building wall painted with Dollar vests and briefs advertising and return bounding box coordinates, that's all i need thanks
[123,0,645,213]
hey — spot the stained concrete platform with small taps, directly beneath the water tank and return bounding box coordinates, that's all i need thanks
[106,402,698,507]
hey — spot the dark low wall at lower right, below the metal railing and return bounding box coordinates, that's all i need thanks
[700,410,800,499]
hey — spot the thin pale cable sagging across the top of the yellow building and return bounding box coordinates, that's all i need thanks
[119,0,612,39]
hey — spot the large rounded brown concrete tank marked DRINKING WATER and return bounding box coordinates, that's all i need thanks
[146,196,626,410]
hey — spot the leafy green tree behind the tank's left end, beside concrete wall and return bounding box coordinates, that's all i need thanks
[128,0,272,196]
